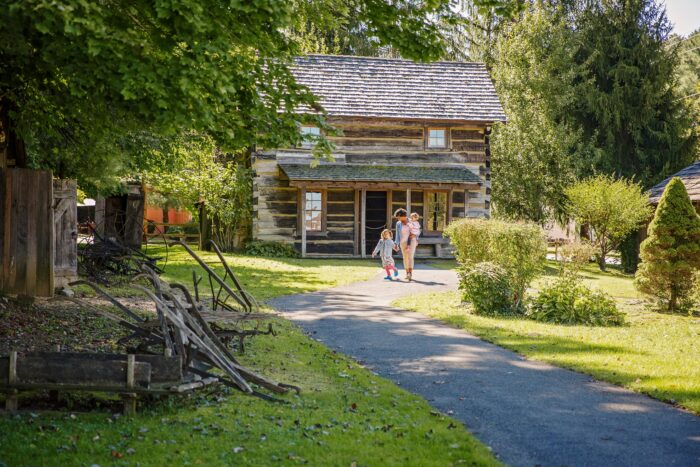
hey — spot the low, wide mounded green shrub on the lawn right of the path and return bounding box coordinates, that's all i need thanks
[527,276,625,326]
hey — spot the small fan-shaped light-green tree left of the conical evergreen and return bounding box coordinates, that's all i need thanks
[565,175,652,271]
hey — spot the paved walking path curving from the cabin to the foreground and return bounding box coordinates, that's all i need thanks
[271,269,700,466]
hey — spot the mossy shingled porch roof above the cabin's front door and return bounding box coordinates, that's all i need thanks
[279,164,482,185]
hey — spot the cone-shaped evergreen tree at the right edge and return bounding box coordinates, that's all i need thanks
[635,177,700,312]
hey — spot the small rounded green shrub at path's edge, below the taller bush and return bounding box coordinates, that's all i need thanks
[459,262,518,316]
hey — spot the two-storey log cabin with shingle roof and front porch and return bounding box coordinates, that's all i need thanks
[252,55,505,257]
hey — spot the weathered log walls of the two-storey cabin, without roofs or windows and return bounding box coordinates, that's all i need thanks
[253,117,491,256]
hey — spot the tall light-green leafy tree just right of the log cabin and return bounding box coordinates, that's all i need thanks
[491,4,590,224]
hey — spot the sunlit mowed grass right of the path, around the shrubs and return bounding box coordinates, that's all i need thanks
[395,262,700,414]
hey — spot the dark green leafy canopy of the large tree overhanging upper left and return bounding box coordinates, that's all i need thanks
[0,0,476,190]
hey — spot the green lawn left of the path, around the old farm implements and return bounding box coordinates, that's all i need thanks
[0,254,498,466]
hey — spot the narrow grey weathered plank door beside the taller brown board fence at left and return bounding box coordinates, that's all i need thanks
[53,180,78,287]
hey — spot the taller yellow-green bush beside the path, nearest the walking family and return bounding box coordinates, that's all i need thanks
[445,219,547,307]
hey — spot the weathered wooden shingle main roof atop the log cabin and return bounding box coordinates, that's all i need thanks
[292,55,505,122]
